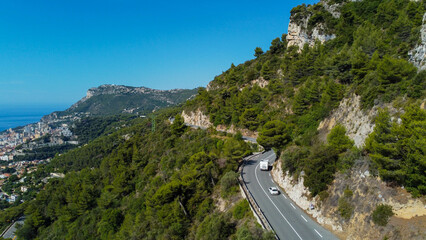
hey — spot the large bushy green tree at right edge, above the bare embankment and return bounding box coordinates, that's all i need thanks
[365,105,426,195]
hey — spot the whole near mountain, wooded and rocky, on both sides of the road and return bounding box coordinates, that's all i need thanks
[4,0,426,239]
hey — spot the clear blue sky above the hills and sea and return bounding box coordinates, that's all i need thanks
[0,0,318,115]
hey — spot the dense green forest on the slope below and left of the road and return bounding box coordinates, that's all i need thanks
[13,109,271,239]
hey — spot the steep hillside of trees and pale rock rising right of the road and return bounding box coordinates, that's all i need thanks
[182,1,426,239]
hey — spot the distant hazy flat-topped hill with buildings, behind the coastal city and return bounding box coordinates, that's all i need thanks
[44,84,197,120]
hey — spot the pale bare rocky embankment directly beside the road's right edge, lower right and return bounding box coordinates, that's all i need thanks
[271,158,426,240]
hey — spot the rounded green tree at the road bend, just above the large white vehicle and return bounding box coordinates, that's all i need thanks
[257,120,291,149]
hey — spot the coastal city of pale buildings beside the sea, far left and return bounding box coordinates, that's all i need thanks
[0,114,81,203]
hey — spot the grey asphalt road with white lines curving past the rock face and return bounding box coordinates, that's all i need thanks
[242,151,338,240]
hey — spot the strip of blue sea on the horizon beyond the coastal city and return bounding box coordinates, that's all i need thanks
[0,105,67,131]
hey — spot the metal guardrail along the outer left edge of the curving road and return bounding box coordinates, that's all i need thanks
[238,155,279,239]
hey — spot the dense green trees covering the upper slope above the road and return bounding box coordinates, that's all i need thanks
[186,0,426,195]
